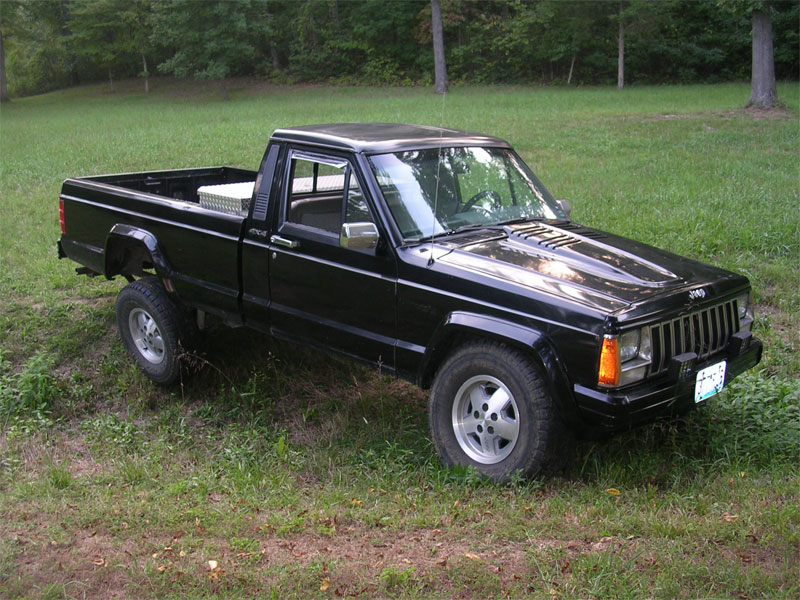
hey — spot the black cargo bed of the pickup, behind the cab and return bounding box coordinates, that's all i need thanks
[59,167,257,322]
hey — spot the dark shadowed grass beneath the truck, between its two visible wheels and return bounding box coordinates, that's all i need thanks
[168,327,439,478]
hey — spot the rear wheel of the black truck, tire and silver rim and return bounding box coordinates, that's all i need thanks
[117,277,184,386]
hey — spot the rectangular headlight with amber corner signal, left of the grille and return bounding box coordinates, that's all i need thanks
[597,327,652,387]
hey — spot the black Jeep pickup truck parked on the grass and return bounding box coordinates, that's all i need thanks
[58,123,762,480]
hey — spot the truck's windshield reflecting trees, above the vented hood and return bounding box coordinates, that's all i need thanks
[370,147,566,241]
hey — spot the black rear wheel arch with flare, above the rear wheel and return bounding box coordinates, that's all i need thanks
[103,223,172,280]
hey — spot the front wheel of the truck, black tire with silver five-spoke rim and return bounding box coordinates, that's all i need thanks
[428,341,572,483]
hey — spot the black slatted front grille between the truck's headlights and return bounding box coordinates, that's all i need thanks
[650,300,739,375]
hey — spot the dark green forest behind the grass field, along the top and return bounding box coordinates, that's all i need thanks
[0,0,800,98]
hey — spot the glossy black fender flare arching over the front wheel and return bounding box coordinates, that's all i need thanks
[418,311,580,426]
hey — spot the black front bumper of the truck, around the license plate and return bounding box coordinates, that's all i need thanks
[573,338,764,432]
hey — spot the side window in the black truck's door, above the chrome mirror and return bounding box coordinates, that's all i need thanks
[285,154,373,237]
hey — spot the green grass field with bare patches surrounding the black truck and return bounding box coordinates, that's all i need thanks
[0,80,800,599]
